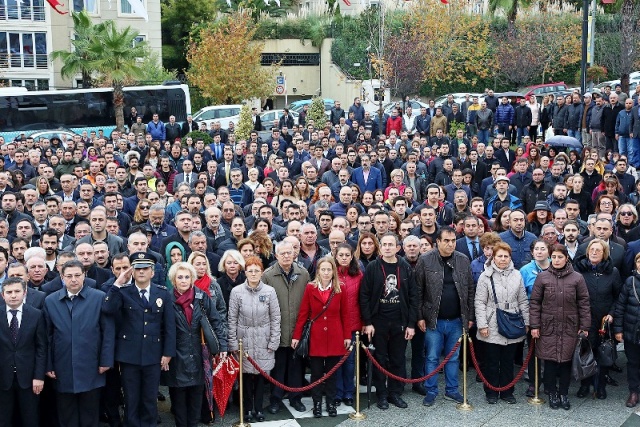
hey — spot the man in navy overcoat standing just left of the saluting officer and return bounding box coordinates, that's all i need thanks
[44,260,115,426]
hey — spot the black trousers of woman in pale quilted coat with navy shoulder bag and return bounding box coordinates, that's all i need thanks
[483,342,518,398]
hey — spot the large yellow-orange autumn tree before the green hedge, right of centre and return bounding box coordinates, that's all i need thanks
[407,0,493,88]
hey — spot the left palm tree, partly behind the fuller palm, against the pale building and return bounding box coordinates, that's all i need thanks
[51,10,104,88]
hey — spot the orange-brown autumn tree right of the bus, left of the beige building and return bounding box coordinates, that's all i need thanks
[187,12,279,104]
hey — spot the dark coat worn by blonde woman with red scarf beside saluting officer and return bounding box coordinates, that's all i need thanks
[161,288,228,387]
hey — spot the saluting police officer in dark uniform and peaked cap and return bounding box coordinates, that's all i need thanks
[104,252,176,427]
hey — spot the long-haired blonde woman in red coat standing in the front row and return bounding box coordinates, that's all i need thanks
[291,256,351,418]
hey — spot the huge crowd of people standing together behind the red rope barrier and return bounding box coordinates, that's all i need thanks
[0,91,640,427]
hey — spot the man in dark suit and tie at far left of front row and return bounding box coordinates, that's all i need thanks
[0,277,47,427]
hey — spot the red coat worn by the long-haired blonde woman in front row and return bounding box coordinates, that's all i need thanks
[293,283,351,357]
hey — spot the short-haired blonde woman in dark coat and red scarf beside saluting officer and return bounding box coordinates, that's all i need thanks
[161,262,227,427]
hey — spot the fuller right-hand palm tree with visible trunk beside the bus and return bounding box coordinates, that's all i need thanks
[87,21,148,131]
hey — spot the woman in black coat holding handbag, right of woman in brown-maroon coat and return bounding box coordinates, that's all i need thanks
[575,239,622,399]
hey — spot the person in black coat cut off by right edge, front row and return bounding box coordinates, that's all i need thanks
[613,254,640,408]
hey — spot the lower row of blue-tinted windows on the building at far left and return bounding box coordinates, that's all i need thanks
[0,31,49,70]
